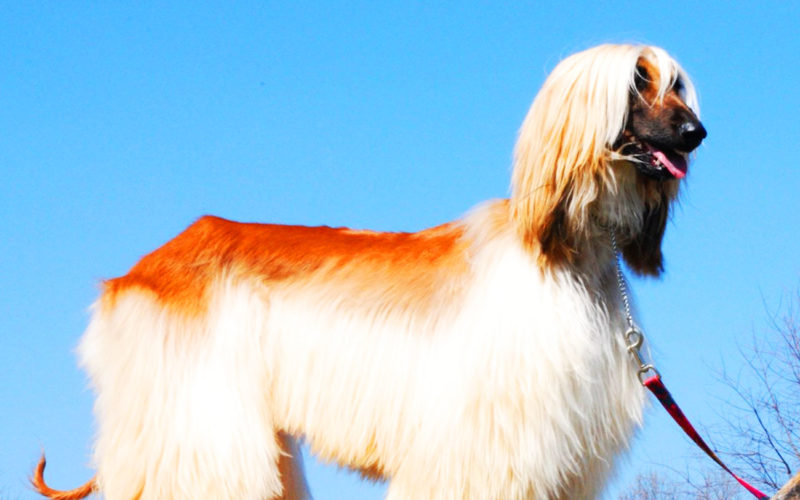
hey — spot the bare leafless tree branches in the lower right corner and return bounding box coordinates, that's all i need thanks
[620,289,800,500]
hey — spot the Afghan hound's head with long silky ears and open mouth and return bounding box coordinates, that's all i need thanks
[511,45,706,275]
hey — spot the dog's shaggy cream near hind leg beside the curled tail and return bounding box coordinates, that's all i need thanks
[80,288,304,500]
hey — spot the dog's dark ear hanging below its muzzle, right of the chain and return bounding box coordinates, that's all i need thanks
[622,197,669,277]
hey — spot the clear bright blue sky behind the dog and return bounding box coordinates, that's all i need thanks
[0,1,800,500]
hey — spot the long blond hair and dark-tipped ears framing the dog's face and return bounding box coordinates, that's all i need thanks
[511,45,696,274]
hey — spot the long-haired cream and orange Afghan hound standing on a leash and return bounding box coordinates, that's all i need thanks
[32,45,706,500]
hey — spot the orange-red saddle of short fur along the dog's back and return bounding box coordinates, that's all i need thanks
[103,216,467,316]
